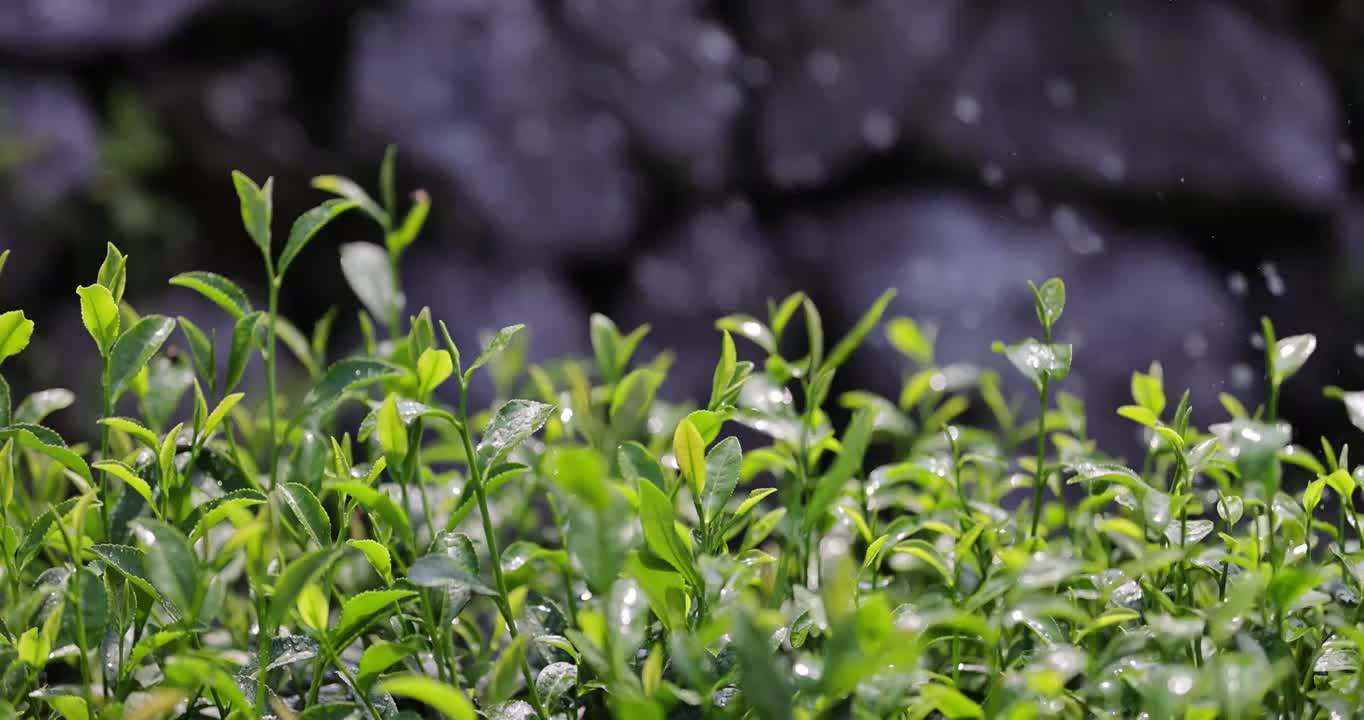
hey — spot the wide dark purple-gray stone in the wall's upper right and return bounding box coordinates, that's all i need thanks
[749,0,1344,211]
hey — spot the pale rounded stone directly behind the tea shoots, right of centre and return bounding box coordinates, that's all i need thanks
[803,194,1254,447]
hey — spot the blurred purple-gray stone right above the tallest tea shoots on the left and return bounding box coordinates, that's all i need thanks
[343,0,638,262]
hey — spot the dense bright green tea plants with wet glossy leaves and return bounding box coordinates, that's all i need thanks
[0,151,1364,720]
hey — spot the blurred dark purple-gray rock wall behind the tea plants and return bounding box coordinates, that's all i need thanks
[0,0,1364,447]
